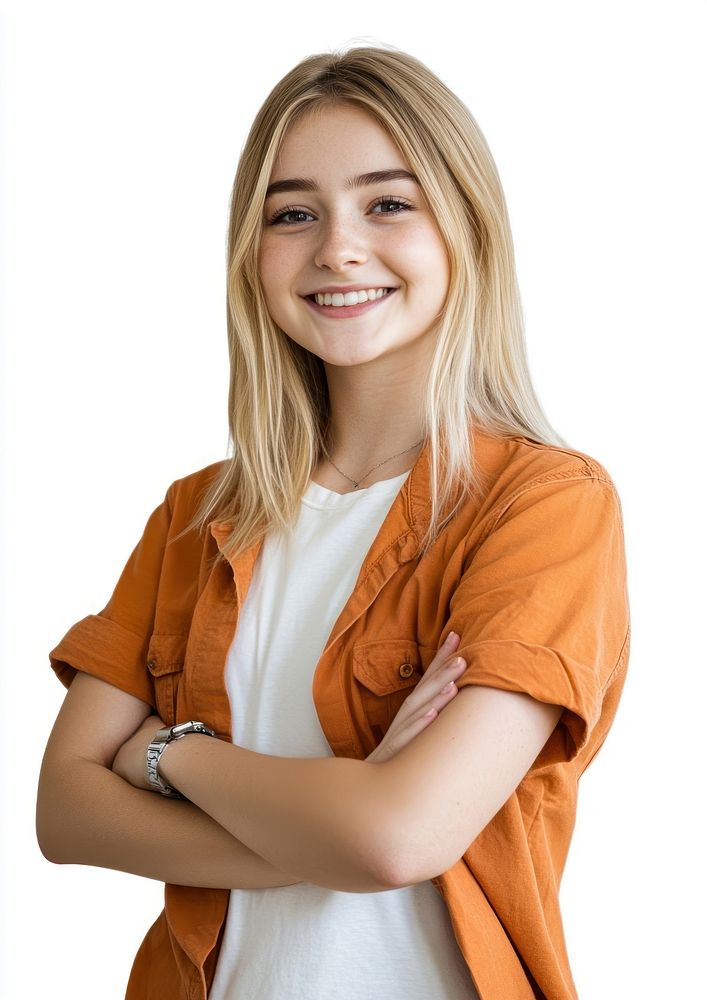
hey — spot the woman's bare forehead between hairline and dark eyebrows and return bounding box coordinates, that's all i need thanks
[270,104,408,181]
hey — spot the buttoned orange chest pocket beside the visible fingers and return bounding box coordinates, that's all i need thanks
[353,639,437,739]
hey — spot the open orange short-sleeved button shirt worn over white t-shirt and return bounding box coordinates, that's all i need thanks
[49,429,630,1000]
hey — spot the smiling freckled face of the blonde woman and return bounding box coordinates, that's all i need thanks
[258,105,449,371]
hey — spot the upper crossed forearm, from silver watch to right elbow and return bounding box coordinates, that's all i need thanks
[159,736,393,892]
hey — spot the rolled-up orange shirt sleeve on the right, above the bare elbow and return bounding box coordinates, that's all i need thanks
[449,476,629,760]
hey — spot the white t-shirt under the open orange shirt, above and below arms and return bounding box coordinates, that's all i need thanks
[209,472,478,1000]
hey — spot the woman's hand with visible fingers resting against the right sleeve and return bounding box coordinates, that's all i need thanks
[366,634,466,764]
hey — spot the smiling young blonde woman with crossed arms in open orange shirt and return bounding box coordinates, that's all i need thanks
[37,48,629,1000]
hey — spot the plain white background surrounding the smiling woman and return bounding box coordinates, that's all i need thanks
[0,0,707,1000]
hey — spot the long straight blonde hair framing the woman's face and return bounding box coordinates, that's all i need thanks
[187,46,567,557]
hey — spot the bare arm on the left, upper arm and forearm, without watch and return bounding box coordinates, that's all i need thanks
[36,672,308,889]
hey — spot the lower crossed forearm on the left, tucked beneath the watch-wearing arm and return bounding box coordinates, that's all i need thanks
[37,760,300,889]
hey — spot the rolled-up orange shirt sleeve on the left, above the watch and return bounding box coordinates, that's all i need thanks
[49,484,174,708]
